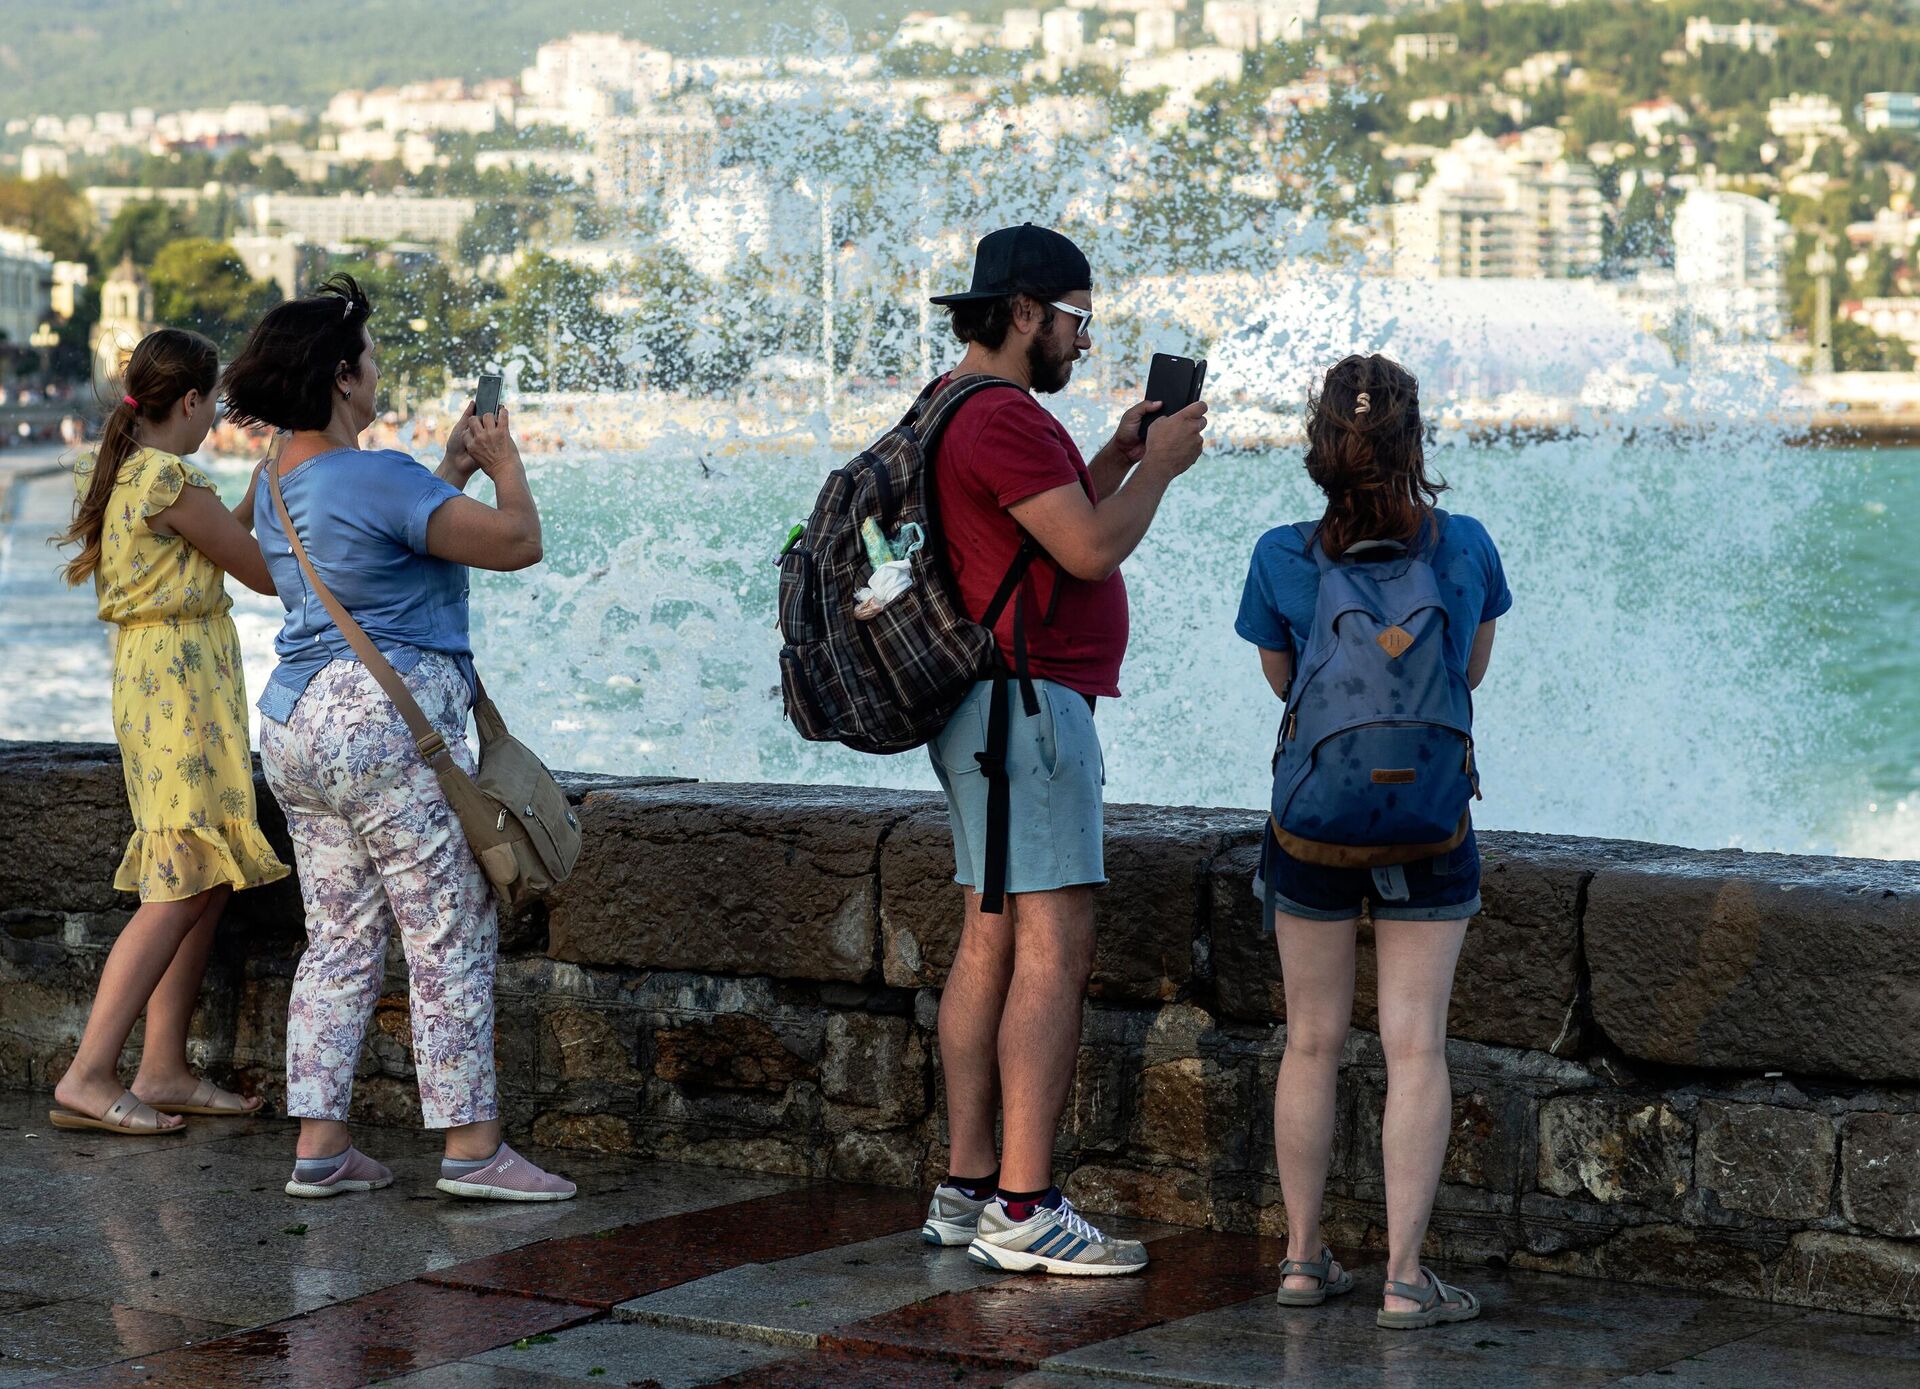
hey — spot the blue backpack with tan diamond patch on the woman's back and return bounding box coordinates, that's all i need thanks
[1273,511,1480,868]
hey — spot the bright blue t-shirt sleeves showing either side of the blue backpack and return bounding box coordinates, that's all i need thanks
[1233,515,1513,670]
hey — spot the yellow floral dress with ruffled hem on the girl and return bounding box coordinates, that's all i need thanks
[75,448,288,901]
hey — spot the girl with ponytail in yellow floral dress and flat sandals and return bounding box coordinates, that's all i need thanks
[48,329,288,1135]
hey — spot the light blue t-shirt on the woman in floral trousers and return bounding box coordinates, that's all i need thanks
[253,448,474,724]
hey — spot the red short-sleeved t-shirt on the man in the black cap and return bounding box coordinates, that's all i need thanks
[933,378,1127,695]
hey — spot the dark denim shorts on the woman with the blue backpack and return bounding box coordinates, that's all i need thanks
[1254,822,1480,930]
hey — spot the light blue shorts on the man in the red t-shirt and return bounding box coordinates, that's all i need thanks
[927,680,1106,891]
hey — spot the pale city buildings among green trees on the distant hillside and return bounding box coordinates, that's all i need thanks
[0,0,1920,405]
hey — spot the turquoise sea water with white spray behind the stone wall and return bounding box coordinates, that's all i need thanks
[11,428,1920,859]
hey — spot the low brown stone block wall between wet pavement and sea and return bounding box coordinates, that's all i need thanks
[0,743,1920,1318]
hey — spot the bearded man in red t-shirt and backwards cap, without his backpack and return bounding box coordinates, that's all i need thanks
[922,223,1206,1274]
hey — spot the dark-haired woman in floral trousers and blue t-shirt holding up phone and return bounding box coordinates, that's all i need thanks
[223,275,574,1201]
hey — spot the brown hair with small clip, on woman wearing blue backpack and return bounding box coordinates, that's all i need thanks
[1308,355,1446,559]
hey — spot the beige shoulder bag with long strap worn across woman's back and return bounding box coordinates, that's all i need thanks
[267,463,580,911]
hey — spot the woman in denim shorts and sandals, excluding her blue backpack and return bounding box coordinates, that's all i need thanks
[1235,355,1513,1328]
